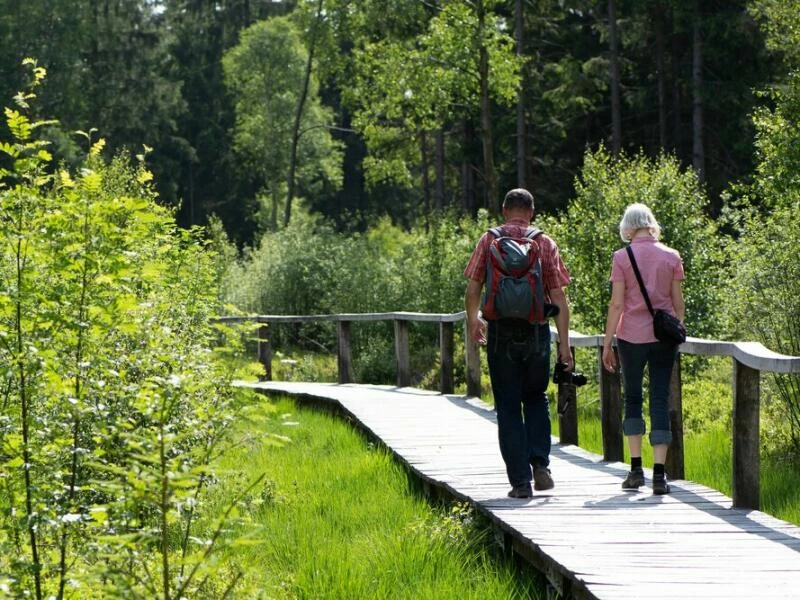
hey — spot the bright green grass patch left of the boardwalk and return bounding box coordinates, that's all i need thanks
[209,400,543,600]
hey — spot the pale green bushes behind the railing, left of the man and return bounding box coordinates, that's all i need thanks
[226,206,488,383]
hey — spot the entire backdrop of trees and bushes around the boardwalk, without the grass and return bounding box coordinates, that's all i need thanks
[0,0,800,597]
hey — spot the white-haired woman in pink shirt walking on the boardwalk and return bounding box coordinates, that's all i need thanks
[603,203,685,494]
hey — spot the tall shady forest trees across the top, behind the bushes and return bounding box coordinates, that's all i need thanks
[0,0,780,247]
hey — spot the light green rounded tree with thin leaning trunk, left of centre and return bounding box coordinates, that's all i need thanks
[223,17,341,229]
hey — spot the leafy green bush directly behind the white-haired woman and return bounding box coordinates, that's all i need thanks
[538,148,724,337]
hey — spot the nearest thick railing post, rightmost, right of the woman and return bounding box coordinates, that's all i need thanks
[732,358,761,510]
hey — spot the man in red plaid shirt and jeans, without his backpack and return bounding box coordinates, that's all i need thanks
[464,188,573,498]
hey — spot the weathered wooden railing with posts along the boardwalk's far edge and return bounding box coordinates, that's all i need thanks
[219,312,800,509]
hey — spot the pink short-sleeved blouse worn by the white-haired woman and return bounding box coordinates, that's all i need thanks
[609,236,685,344]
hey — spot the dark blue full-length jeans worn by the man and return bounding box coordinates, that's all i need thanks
[486,320,550,485]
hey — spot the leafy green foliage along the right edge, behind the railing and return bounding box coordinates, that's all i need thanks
[723,0,800,452]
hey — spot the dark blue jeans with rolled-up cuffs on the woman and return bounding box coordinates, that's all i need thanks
[617,339,678,446]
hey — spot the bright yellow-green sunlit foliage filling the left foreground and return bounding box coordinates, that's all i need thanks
[0,61,258,599]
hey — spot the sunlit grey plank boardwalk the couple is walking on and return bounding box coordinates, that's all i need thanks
[246,382,800,600]
